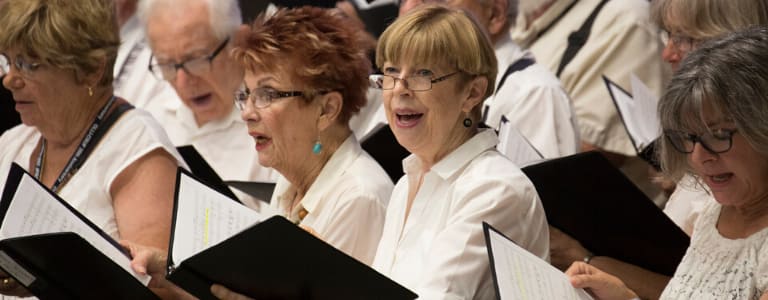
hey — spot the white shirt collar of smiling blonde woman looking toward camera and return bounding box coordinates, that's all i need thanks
[403,129,499,180]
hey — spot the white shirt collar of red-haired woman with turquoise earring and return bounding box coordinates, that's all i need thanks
[272,134,363,220]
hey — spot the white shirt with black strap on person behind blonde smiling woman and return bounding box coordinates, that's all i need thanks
[485,35,580,158]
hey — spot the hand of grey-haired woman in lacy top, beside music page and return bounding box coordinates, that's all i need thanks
[565,262,637,300]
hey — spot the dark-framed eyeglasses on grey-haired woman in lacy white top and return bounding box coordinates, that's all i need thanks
[664,129,737,154]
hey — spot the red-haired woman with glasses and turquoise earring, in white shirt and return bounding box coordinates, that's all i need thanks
[127,7,393,298]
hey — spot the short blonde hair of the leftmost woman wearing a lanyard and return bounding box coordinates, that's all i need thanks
[0,0,120,86]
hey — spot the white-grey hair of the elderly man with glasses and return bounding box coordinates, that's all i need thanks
[136,0,243,40]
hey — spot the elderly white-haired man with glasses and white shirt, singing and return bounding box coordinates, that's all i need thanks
[138,0,275,207]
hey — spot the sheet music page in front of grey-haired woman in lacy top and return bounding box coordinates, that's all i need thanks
[488,229,592,300]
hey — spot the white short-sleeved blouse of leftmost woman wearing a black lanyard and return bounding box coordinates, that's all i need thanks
[0,109,186,239]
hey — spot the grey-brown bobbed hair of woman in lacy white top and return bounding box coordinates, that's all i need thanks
[658,27,768,180]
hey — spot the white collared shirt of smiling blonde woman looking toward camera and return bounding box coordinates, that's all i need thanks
[373,130,549,299]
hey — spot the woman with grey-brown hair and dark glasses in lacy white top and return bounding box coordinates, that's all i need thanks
[567,27,768,299]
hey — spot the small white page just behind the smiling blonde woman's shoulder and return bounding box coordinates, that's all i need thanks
[496,116,543,167]
